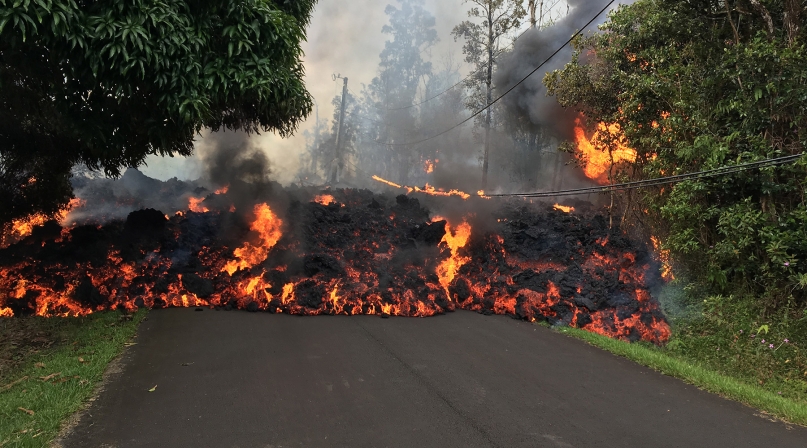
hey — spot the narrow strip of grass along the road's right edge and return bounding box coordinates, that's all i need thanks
[558,328,807,426]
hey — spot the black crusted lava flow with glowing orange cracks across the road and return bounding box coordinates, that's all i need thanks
[0,189,669,344]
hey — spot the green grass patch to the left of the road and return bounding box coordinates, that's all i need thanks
[0,312,146,447]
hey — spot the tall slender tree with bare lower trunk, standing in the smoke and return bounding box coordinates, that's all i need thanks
[451,0,527,189]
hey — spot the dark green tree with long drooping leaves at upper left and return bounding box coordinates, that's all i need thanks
[0,0,316,224]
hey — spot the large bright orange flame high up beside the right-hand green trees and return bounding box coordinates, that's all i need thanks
[574,118,636,185]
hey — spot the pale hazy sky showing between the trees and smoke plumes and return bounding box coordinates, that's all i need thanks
[141,0,625,184]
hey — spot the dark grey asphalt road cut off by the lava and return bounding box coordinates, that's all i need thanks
[66,309,807,448]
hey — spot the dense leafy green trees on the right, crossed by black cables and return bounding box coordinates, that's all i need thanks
[545,0,807,308]
